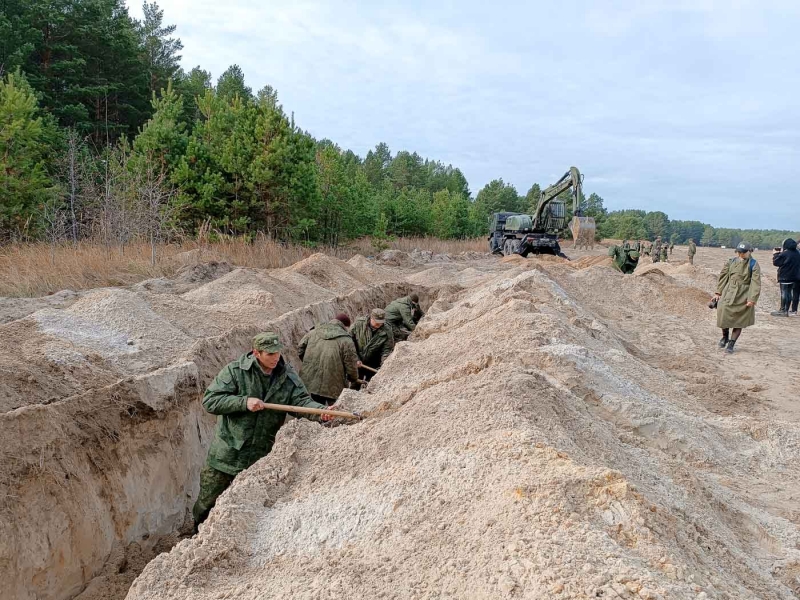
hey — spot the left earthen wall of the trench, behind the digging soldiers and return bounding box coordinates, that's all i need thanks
[0,282,435,600]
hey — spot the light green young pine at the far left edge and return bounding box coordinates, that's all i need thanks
[0,72,52,239]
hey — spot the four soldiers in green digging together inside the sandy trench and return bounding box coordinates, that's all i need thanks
[192,294,424,530]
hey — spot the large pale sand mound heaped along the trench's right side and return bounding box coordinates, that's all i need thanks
[128,266,800,600]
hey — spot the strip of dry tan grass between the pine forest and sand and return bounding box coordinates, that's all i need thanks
[0,238,486,297]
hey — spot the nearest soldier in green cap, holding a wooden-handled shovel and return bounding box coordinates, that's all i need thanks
[192,332,327,528]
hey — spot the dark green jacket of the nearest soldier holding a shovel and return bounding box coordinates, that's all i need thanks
[203,352,326,475]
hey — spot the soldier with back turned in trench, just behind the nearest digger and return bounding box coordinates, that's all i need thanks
[297,313,361,406]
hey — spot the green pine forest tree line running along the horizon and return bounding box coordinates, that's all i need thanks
[0,0,788,249]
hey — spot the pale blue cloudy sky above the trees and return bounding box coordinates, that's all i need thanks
[128,0,800,231]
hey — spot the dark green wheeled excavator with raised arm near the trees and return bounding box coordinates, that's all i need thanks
[489,167,596,257]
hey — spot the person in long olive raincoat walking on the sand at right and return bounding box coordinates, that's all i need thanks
[715,242,761,354]
